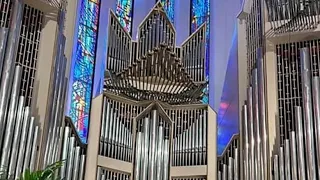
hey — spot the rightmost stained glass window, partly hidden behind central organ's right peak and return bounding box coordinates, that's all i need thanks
[191,0,210,103]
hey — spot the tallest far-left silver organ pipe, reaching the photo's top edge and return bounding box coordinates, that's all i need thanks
[0,0,24,148]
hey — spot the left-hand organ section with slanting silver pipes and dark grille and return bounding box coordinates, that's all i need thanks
[0,0,86,180]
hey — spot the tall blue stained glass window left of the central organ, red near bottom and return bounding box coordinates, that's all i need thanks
[69,0,100,143]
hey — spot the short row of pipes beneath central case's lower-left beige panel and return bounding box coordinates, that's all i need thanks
[97,167,130,180]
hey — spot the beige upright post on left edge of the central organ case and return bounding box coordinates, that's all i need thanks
[85,94,103,180]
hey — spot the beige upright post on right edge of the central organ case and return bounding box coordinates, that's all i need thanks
[207,106,217,179]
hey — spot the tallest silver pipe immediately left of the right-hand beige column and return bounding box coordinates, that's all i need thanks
[257,48,269,179]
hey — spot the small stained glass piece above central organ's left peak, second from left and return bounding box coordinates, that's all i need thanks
[116,0,133,34]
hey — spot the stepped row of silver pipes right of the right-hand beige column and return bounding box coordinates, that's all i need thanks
[272,48,320,180]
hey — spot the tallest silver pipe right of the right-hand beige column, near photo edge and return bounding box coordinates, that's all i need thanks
[300,48,317,180]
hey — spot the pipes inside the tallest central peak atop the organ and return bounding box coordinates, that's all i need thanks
[137,5,175,59]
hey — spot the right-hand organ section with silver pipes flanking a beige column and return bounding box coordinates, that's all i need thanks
[232,0,320,180]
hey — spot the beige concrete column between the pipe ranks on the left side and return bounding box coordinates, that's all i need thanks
[32,13,58,169]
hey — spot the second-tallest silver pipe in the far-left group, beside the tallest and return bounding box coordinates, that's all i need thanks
[0,66,23,167]
